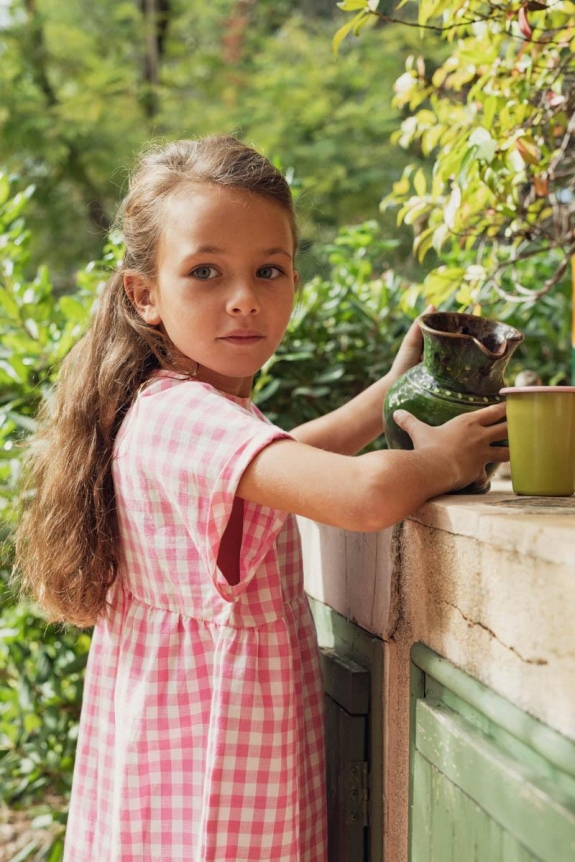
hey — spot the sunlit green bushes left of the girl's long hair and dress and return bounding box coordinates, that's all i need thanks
[0,175,117,862]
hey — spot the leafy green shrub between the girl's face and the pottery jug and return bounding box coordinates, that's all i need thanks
[254,221,417,438]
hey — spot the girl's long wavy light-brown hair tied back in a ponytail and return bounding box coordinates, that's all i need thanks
[15,136,297,627]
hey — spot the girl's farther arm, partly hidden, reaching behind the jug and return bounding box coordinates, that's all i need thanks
[290,314,422,455]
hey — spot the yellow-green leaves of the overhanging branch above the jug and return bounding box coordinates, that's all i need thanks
[336,0,575,307]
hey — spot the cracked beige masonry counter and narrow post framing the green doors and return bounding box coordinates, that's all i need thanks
[301,483,575,862]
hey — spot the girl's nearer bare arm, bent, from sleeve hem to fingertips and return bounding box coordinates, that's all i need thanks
[237,404,509,531]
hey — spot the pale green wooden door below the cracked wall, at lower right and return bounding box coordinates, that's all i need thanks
[410,645,575,862]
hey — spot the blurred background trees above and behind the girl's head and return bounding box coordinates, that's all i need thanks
[0,0,432,289]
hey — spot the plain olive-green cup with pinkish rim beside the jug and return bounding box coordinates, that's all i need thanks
[500,386,575,497]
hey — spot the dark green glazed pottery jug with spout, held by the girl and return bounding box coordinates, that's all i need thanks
[384,311,523,493]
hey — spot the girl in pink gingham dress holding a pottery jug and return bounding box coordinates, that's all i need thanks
[14,137,508,862]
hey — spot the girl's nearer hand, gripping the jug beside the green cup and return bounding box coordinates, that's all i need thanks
[393,403,509,491]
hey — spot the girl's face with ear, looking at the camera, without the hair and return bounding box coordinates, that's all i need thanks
[126,184,298,396]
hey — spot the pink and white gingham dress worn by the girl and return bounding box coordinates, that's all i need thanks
[64,372,327,862]
